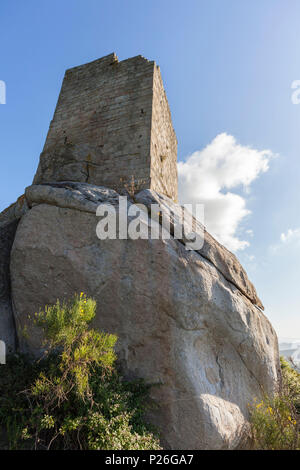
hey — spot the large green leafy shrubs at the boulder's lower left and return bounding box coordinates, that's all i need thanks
[0,293,160,450]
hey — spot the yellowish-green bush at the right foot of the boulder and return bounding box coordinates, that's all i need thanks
[251,358,300,450]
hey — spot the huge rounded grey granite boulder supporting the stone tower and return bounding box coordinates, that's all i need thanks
[10,183,279,449]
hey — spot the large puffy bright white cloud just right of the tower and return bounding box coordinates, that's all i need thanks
[178,133,274,251]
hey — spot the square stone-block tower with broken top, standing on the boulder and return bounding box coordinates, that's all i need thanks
[34,53,177,201]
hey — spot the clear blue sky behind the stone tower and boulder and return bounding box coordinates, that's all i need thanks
[0,0,300,337]
